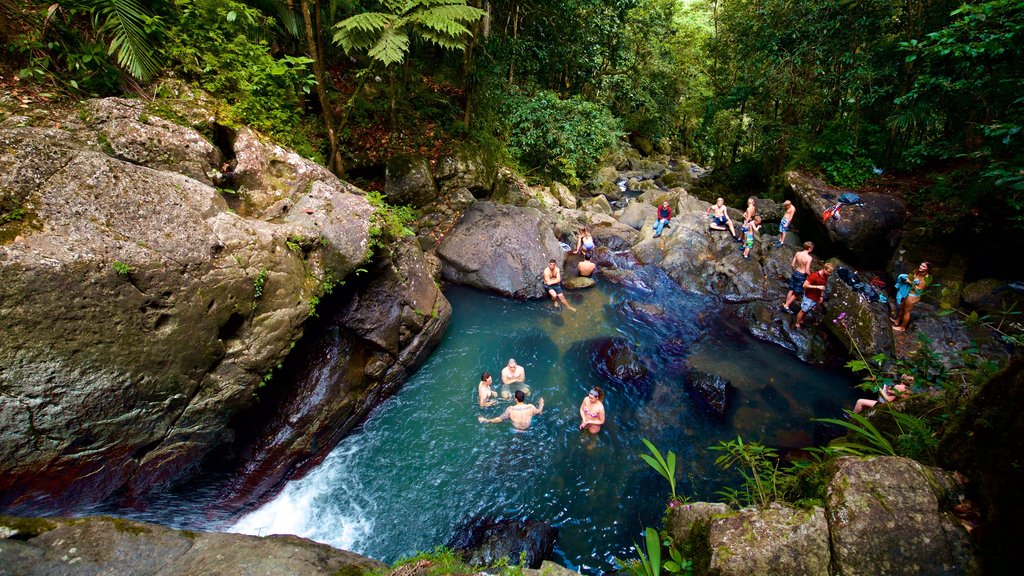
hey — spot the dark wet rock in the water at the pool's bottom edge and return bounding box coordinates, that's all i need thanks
[447,518,558,569]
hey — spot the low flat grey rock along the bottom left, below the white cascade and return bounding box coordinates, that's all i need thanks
[0,510,385,576]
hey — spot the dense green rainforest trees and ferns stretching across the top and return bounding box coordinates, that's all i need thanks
[0,0,1024,219]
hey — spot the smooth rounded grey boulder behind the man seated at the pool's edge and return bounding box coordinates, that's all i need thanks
[437,202,565,298]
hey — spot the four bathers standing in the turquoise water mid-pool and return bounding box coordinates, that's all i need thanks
[476,358,605,434]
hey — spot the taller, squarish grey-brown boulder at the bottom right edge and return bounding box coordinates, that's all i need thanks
[826,457,981,576]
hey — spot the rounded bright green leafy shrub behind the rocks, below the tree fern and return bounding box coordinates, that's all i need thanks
[503,90,622,187]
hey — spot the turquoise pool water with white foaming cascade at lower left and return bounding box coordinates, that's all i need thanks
[232,259,857,573]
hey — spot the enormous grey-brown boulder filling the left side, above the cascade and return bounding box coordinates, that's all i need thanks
[0,96,395,510]
